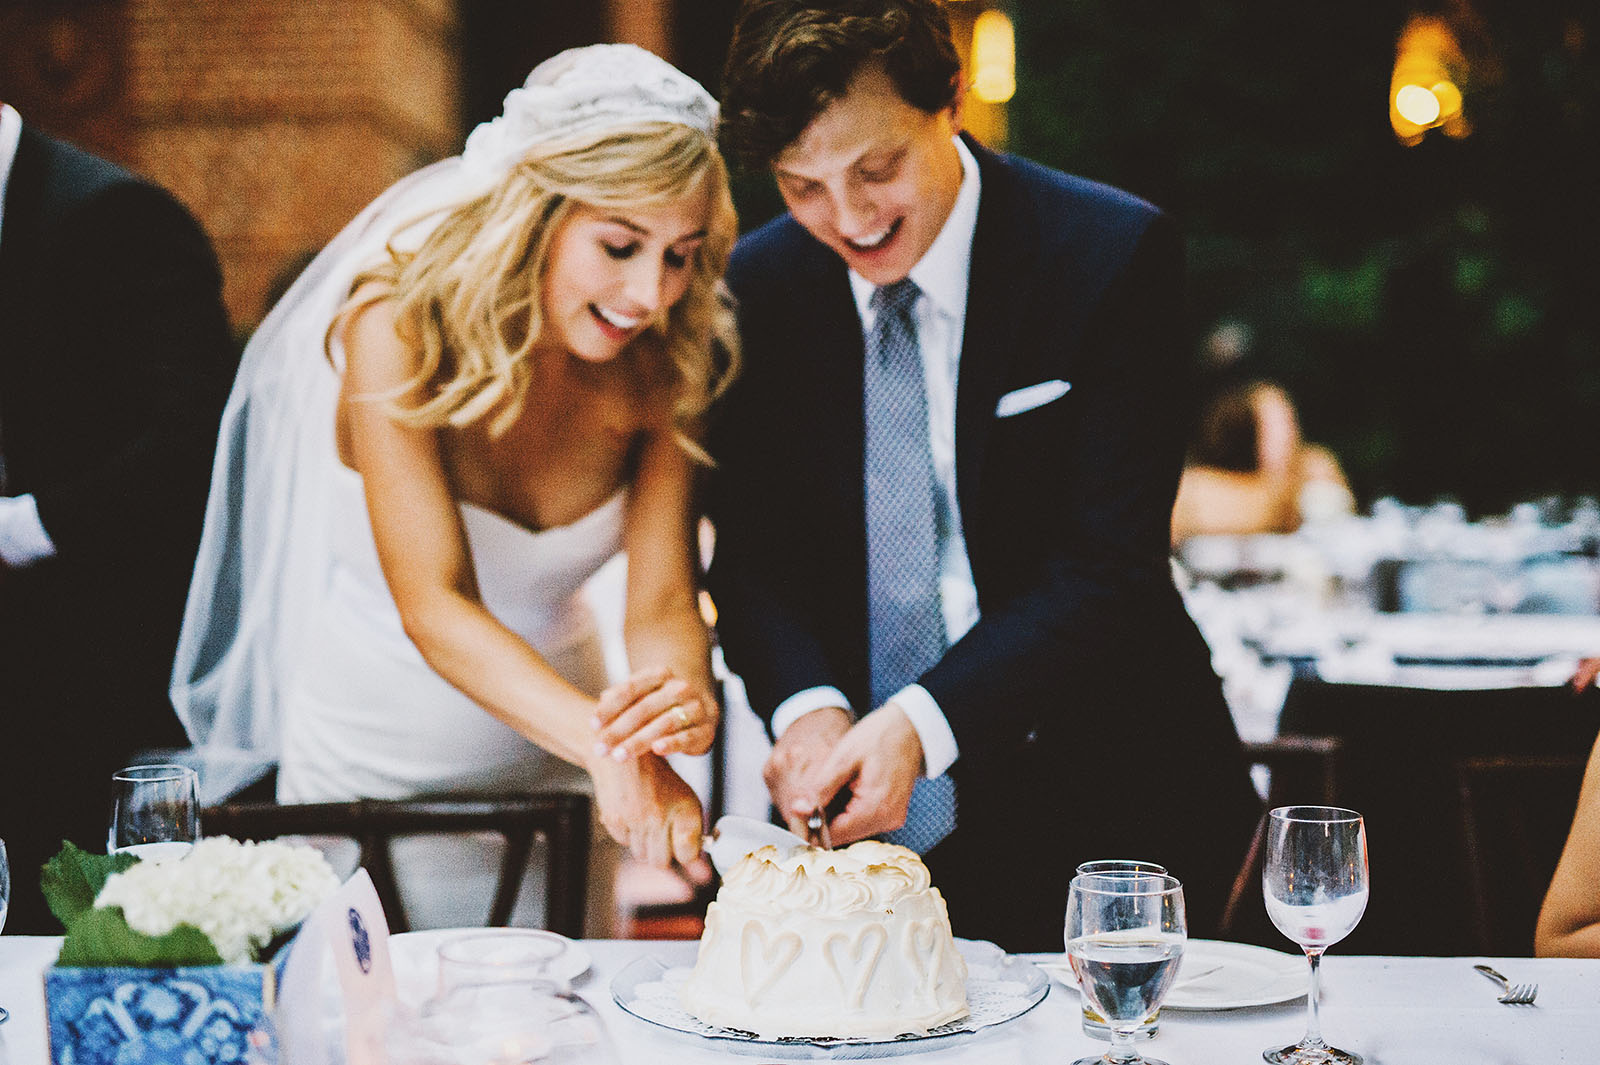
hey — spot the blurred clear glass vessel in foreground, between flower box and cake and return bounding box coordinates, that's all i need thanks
[389,929,618,1065]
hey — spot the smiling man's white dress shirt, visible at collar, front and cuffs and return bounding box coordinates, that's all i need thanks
[773,138,979,777]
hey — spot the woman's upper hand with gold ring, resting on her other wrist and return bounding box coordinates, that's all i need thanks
[595,667,722,761]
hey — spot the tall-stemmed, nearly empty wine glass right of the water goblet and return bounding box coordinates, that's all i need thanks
[1261,806,1366,1065]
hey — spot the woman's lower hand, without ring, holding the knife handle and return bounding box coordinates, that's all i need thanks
[589,753,704,868]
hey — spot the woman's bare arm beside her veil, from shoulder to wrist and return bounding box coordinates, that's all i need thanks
[339,301,595,768]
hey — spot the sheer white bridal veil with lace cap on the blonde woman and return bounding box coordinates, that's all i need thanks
[171,45,717,795]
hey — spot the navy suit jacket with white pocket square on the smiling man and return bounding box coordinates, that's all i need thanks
[709,141,1256,950]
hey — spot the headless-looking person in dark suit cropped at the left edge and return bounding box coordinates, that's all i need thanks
[0,104,234,932]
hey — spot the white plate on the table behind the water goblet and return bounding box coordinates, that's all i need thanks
[1038,939,1310,1009]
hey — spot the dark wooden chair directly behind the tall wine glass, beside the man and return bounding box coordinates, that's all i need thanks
[1219,734,1344,945]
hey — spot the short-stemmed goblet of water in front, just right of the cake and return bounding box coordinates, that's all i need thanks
[1066,873,1187,1065]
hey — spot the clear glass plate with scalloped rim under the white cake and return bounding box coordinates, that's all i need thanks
[611,939,1050,1060]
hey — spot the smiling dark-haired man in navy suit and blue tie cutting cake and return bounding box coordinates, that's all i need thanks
[709,0,1258,950]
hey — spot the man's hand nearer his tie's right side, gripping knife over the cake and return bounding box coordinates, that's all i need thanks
[789,702,923,846]
